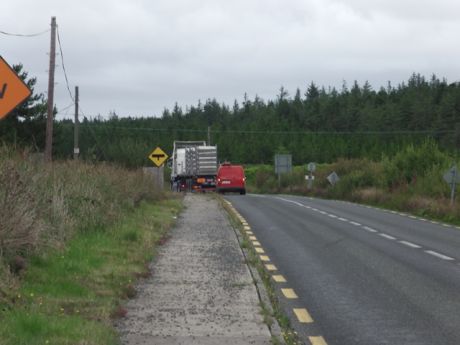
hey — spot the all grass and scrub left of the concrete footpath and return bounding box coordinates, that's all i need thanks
[0,146,181,345]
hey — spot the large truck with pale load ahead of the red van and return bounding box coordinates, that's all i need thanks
[171,141,217,191]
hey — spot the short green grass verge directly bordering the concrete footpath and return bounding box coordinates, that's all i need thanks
[0,199,182,345]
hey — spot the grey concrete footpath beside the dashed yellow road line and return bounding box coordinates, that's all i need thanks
[118,194,270,345]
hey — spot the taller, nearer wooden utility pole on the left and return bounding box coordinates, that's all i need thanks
[45,17,56,162]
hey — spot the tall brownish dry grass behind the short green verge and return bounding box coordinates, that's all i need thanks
[0,146,162,299]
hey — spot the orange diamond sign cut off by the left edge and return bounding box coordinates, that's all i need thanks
[0,56,32,119]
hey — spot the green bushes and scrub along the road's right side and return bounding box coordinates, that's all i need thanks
[245,140,460,225]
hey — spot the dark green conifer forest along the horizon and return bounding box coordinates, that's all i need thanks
[0,69,460,167]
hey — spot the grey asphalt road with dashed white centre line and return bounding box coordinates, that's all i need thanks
[225,195,460,345]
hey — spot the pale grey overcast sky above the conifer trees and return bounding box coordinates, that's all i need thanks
[0,0,460,118]
